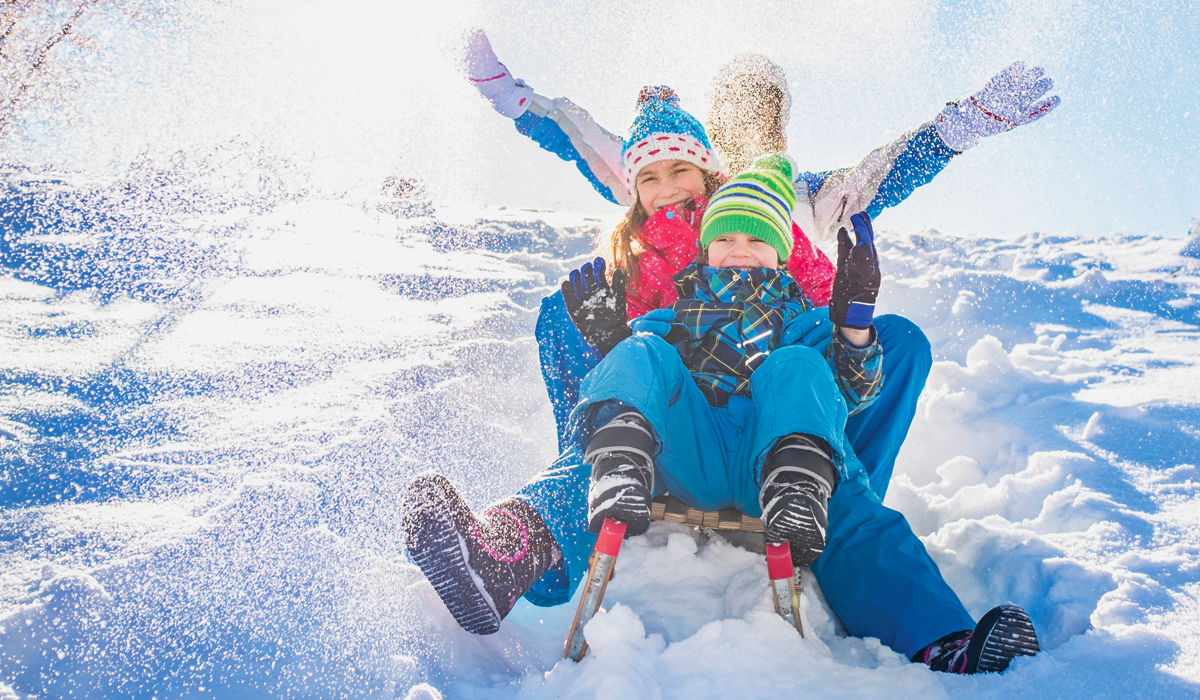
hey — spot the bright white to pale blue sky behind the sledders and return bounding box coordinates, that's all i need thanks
[18,0,1200,235]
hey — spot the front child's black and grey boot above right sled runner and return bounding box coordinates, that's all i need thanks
[758,433,838,567]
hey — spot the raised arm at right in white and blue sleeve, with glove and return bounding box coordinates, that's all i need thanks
[796,61,1060,240]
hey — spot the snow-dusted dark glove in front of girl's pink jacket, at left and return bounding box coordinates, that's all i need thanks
[562,258,633,355]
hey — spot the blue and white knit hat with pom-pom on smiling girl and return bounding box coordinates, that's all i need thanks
[620,85,721,192]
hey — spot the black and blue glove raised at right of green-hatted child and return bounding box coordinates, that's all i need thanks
[829,211,881,329]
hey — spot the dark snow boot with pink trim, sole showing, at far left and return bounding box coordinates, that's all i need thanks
[402,474,563,634]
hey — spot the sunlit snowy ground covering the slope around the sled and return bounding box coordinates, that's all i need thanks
[0,172,1200,699]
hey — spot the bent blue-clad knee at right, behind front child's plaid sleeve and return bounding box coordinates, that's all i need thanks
[846,315,934,501]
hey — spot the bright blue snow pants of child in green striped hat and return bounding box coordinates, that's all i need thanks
[571,334,846,517]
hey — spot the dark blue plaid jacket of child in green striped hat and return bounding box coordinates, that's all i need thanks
[670,263,883,415]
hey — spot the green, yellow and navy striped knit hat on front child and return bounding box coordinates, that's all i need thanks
[700,154,796,261]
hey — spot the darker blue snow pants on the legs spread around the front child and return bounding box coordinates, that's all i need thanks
[517,293,974,656]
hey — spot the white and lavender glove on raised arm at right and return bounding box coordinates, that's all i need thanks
[934,61,1060,151]
